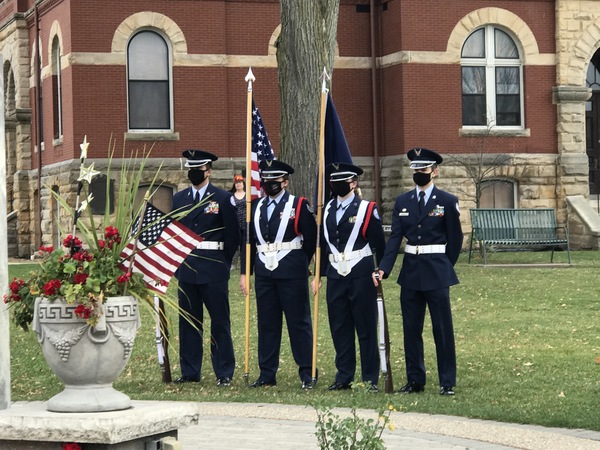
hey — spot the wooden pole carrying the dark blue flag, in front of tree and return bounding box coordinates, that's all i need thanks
[312,68,329,383]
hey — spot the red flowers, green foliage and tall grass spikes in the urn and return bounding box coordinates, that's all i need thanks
[4,138,173,330]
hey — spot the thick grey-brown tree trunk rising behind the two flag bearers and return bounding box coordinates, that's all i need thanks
[276,0,339,204]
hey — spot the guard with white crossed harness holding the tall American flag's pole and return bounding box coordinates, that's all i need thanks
[240,160,317,389]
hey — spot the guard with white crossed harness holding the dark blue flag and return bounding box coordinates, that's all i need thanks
[312,163,385,392]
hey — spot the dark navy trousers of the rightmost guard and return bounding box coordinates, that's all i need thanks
[400,287,456,387]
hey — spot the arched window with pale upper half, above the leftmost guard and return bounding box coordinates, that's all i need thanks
[127,30,172,131]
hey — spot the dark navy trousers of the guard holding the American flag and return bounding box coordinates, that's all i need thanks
[254,275,312,382]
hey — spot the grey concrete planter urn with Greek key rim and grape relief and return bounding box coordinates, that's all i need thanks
[33,296,140,413]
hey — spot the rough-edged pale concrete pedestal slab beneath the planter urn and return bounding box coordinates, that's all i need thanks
[0,401,199,450]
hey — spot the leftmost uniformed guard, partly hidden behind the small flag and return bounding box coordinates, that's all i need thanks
[173,150,240,386]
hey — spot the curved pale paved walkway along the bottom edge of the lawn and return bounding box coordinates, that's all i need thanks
[179,403,600,450]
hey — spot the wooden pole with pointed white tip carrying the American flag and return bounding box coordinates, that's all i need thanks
[244,67,256,384]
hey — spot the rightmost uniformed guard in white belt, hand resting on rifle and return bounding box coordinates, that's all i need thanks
[373,148,463,395]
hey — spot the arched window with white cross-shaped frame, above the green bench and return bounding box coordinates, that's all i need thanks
[461,25,524,129]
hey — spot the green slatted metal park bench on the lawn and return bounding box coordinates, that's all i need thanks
[469,208,571,264]
